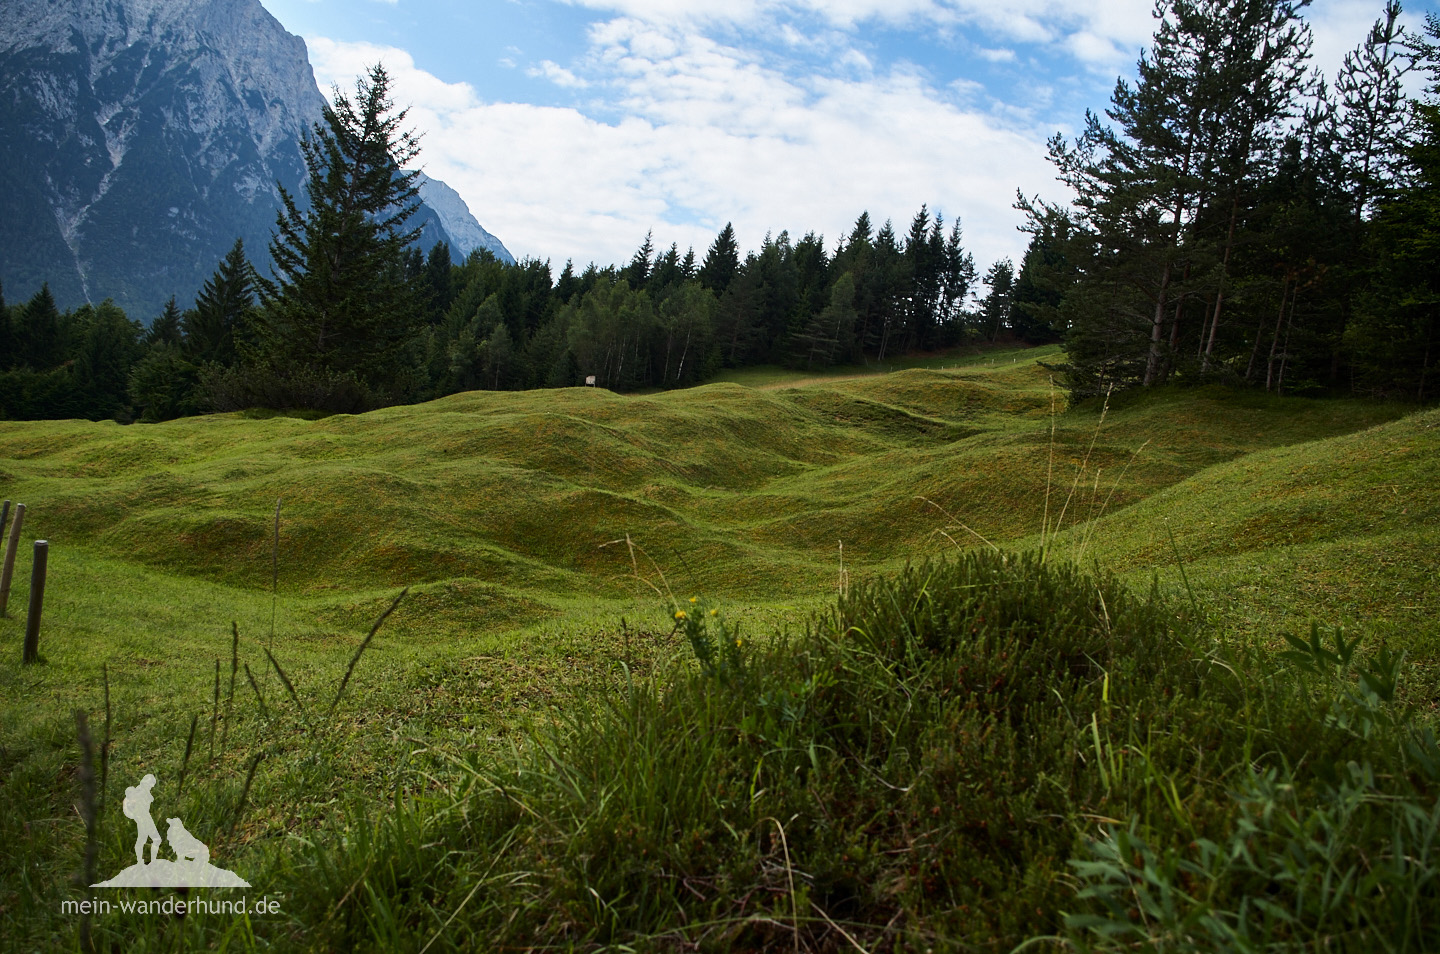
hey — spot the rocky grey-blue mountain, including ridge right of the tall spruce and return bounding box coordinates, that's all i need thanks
[0,0,510,321]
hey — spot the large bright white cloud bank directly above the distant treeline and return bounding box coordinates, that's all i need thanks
[308,16,1058,268]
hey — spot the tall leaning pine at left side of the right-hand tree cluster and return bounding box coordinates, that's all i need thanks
[1051,0,1310,386]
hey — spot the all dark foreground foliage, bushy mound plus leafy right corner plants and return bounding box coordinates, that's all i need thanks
[280,552,1440,951]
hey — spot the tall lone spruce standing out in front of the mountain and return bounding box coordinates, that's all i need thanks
[256,65,422,404]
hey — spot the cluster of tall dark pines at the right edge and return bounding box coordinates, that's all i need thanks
[1014,0,1440,401]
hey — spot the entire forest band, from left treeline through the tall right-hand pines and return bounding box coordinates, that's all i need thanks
[0,0,1440,421]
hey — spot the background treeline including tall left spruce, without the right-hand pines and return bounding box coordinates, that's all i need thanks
[0,66,1047,421]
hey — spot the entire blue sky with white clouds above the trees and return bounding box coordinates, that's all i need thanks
[262,0,1437,271]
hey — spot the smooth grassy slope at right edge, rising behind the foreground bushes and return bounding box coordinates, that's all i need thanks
[1030,406,1440,710]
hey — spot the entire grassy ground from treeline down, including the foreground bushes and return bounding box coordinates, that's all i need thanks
[0,349,1440,951]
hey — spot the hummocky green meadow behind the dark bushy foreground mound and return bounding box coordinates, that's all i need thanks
[0,349,1440,950]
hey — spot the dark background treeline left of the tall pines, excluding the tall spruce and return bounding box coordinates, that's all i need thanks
[0,208,1019,421]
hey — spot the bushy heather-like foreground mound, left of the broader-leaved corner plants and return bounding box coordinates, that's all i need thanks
[286,553,1232,950]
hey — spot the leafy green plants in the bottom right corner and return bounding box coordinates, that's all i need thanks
[1066,625,1440,951]
